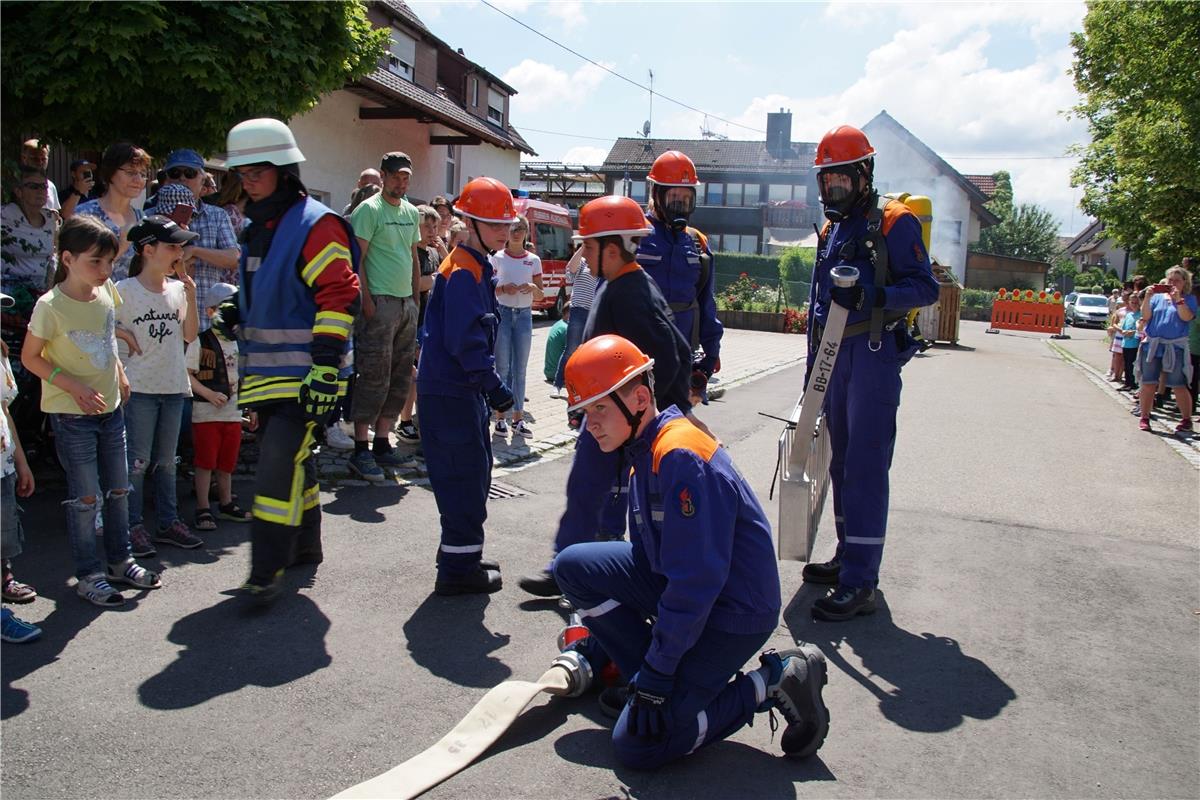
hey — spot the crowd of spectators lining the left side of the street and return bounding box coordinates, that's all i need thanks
[0,139,588,642]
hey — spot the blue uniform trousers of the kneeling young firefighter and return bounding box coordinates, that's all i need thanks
[554,542,770,769]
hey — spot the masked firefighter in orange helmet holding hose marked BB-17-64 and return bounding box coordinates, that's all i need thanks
[804,125,937,620]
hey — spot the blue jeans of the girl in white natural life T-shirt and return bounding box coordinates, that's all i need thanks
[125,392,186,530]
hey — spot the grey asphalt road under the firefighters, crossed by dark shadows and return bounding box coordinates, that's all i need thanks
[0,323,1200,800]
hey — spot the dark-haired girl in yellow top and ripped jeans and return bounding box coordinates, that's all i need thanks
[20,216,162,608]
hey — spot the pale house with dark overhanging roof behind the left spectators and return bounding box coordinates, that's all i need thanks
[265,0,536,209]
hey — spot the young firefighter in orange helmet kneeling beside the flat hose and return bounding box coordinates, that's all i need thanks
[554,336,829,769]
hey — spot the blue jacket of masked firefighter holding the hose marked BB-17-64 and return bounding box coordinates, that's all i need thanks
[809,200,937,341]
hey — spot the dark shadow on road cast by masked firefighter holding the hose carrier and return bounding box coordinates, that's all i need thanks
[784,587,1016,733]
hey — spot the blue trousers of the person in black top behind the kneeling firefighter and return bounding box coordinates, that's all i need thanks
[552,417,629,553]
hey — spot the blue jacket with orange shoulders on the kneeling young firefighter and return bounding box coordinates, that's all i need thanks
[626,408,780,675]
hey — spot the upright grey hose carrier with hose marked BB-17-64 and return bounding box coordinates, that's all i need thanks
[772,266,858,561]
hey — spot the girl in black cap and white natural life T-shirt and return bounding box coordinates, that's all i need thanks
[116,215,204,557]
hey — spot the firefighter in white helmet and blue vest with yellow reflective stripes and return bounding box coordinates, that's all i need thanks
[216,119,359,602]
